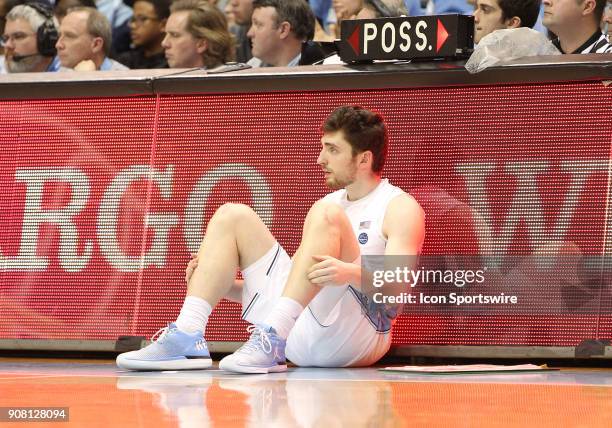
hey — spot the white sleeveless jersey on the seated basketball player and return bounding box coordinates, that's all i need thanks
[323,179,405,256]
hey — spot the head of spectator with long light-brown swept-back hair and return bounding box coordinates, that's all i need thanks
[162,0,234,68]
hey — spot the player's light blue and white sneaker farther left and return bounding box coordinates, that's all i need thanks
[117,323,212,370]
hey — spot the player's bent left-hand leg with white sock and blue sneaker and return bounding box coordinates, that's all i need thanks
[117,204,276,370]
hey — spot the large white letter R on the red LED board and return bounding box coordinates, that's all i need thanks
[0,168,93,272]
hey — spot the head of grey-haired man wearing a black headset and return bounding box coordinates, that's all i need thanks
[2,3,60,73]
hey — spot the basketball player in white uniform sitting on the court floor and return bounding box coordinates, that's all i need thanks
[117,107,425,373]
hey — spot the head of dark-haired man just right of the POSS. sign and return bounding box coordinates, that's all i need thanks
[474,0,541,43]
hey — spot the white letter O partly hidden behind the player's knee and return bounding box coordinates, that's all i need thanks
[184,163,272,253]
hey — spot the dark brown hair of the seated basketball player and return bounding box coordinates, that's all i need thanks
[321,106,388,174]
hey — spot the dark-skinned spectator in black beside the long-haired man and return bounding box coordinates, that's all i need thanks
[115,0,170,69]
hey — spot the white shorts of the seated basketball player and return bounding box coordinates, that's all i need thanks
[242,243,391,367]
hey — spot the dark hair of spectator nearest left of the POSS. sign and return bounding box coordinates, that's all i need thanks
[253,0,315,41]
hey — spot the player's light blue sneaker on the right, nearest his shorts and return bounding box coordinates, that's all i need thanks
[219,325,287,373]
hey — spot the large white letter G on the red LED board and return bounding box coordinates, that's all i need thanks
[98,165,179,272]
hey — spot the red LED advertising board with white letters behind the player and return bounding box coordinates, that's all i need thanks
[0,83,612,346]
